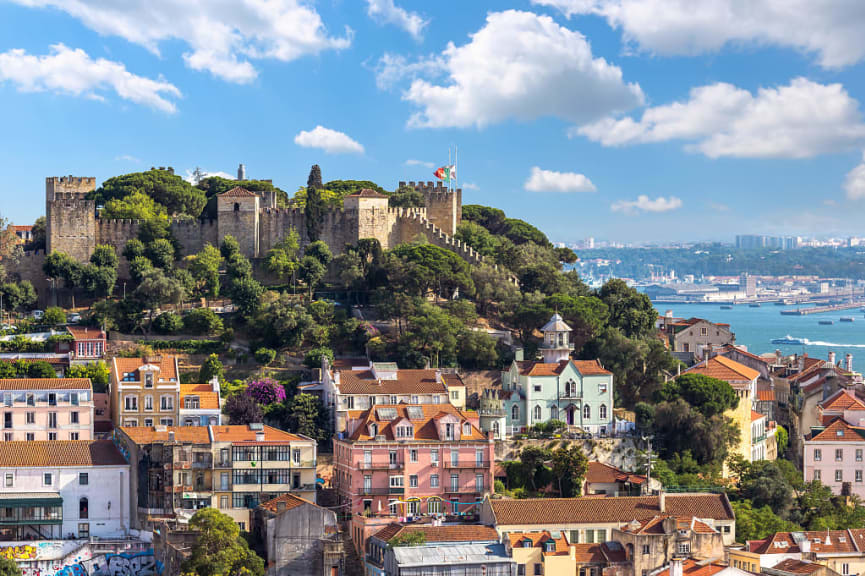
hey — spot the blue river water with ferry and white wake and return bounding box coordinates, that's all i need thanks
[655,303,865,370]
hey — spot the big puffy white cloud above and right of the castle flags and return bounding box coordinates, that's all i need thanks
[391,10,643,128]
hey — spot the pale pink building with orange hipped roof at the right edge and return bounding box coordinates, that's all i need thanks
[803,418,865,498]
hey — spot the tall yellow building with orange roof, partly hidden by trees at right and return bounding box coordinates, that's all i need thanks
[683,356,760,476]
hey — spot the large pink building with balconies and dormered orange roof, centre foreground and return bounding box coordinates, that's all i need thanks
[333,404,494,516]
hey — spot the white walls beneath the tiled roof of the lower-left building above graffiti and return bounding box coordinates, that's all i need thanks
[0,464,129,538]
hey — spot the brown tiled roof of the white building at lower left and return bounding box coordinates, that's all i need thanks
[0,440,126,468]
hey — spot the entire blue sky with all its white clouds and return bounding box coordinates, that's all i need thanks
[0,0,865,241]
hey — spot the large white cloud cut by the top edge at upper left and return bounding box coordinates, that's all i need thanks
[13,0,352,82]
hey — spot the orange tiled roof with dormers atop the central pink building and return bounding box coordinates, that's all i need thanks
[347,403,487,442]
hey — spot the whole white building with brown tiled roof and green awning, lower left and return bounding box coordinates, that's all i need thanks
[0,440,130,541]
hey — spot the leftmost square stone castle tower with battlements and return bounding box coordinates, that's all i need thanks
[45,176,96,262]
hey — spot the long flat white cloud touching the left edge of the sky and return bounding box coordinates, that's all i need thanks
[0,44,181,113]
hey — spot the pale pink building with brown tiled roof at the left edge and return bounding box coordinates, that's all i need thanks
[0,378,94,442]
